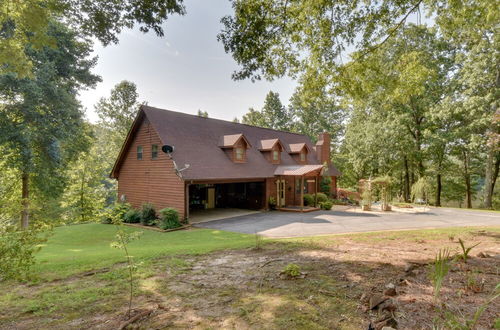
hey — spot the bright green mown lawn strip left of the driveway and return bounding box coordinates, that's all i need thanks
[34,224,255,280]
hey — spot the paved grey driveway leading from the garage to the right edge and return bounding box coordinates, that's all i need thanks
[196,208,500,237]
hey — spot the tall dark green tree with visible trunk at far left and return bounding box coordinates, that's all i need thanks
[0,22,100,228]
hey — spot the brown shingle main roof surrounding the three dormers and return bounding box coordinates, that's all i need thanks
[113,105,340,180]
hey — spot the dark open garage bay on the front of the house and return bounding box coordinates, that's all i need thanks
[189,182,265,222]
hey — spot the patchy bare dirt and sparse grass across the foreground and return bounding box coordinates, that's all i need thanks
[0,229,500,329]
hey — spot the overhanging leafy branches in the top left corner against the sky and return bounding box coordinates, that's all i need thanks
[0,0,185,76]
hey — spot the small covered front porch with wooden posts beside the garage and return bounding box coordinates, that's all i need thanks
[274,165,323,212]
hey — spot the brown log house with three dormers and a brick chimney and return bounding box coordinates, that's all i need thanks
[111,105,340,219]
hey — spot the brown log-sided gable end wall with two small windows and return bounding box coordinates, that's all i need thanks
[118,119,186,219]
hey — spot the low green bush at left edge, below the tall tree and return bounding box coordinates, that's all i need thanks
[0,221,47,281]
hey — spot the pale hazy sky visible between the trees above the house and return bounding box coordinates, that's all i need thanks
[79,0,296,121]
